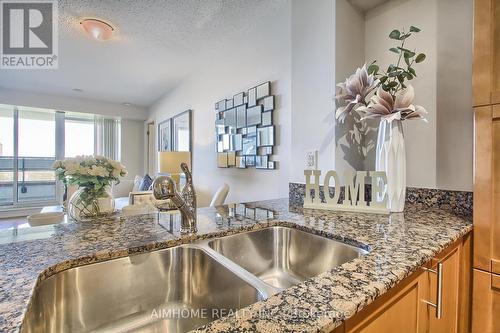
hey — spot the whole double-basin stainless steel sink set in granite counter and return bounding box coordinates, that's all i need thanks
[22,226,366,332]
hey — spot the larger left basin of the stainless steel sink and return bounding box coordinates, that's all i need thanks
[22,246,264,333]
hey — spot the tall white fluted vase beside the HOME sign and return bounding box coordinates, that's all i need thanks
[375,120,406,212]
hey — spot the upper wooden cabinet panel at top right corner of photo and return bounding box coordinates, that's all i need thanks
[472,0,493,106]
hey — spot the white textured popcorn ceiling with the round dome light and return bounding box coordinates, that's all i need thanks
[0,0,288,106]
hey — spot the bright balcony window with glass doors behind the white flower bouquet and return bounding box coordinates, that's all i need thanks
[0,104,120,209]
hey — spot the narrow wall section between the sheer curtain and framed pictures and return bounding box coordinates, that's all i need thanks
[121,119,145,179]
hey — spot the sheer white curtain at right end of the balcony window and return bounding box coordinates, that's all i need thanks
[94,116,121,160]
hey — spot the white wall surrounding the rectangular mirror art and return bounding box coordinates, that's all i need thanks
[146,3,291,206]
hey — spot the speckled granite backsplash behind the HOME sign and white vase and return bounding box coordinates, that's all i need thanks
[288,183,472,218]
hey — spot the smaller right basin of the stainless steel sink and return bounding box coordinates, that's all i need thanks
[208,227,366,289]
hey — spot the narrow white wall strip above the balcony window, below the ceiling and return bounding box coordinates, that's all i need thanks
[0,88,148,120]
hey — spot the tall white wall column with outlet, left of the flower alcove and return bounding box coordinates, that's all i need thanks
[291,0,335,182]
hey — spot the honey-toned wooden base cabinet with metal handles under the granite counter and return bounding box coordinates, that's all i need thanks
[334,235,471,333]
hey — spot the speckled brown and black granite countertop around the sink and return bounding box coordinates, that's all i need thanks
[0,199,472,332]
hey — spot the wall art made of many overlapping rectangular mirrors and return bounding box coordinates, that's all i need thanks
[215,82,276,169]
